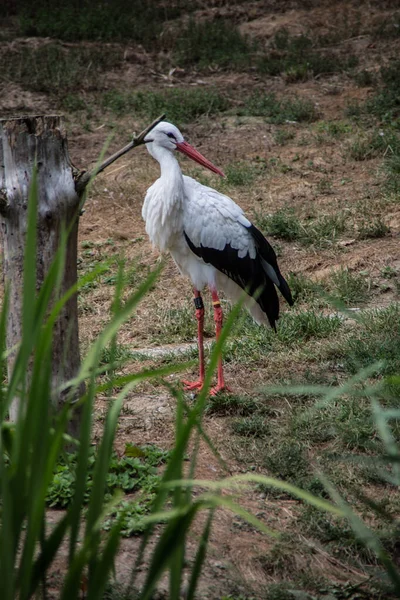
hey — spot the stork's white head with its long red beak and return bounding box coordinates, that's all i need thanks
[144,121,225,177]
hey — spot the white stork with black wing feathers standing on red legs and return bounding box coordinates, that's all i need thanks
[142,121,293,395]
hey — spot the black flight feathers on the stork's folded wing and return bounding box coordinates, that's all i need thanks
[184,225,293,329]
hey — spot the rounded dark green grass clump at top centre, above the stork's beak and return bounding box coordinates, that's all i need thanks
[173,19,256,69]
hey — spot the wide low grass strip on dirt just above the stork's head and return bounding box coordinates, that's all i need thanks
[103,88,229,123]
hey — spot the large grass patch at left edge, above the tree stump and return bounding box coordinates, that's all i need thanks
[0,42,122,96]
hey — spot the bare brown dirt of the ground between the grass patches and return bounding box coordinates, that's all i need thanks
[0,1,400,599]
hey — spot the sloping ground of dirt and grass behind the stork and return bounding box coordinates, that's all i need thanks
[1,5,400,598]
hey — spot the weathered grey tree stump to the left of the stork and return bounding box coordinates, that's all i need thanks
[0,116,80,435]
